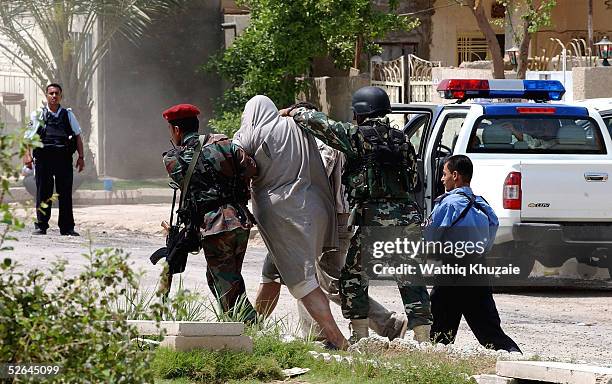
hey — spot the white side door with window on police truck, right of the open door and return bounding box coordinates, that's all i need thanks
[424,108,469,214]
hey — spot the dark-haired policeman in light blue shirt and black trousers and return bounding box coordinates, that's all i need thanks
[424,155,520,352]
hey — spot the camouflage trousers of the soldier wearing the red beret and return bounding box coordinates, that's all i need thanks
[202,228,256,322]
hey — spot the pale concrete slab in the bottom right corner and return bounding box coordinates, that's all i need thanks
[496,361,612,384]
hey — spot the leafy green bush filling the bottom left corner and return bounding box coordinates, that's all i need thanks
[0,249,158,383]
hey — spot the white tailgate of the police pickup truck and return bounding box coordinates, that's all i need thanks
[520,160,612,222]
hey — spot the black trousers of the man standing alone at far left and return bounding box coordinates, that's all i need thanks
[34,147,74,232]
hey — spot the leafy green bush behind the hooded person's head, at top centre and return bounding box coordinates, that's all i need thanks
[203,0,418,111]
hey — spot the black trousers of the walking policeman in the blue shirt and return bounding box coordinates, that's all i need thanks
[431,286,520,352]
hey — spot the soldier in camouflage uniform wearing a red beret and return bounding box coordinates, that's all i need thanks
[162,104,256,322]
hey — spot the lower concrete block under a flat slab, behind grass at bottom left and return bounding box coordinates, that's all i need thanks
[160,336,253,352]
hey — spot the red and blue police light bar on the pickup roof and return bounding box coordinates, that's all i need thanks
[438,79,565,101]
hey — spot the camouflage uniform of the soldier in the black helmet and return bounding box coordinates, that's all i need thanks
[294,108,432,329]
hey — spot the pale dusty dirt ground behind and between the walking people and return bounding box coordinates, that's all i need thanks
[11,204,612,366]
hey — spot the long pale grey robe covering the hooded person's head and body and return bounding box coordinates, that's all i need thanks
[234,96,337,299]
